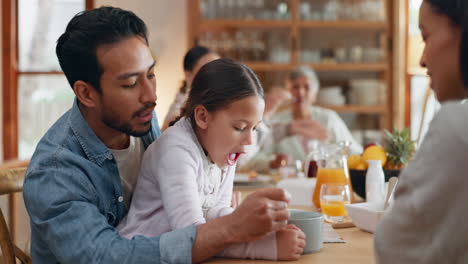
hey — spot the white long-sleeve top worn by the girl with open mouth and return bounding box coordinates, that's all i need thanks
[118,118,277,260]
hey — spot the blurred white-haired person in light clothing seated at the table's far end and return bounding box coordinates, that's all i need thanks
[243,66,362,171]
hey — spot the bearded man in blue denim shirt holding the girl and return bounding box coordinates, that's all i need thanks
[23,7,289,264]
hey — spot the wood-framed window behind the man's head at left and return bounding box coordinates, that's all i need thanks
[2,0,93,159]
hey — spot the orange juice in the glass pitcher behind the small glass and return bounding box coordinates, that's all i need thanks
[312,168,353,209]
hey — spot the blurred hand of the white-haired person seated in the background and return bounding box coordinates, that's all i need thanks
[289,120,329,140]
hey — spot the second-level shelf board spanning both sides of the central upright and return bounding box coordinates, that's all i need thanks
[244,62,388,72]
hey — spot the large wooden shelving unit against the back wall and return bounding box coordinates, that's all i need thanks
[187,0,394,129]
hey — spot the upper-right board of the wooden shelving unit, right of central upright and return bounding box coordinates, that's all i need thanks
[299,21,388,30]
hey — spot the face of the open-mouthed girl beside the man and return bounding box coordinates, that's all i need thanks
[197,95,265,168]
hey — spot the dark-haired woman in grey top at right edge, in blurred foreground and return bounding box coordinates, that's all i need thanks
[375,0,468,264]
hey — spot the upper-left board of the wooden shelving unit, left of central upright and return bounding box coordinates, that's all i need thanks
[200,19,292,30]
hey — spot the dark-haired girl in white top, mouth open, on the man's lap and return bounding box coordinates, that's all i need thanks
[119,59,305,260]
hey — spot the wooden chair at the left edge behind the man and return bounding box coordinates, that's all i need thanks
[0,167,32,264]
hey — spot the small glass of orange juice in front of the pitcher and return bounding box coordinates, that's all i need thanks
[320,183,351,223]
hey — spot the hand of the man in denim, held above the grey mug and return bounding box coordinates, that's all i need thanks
[229,188,291,243]
